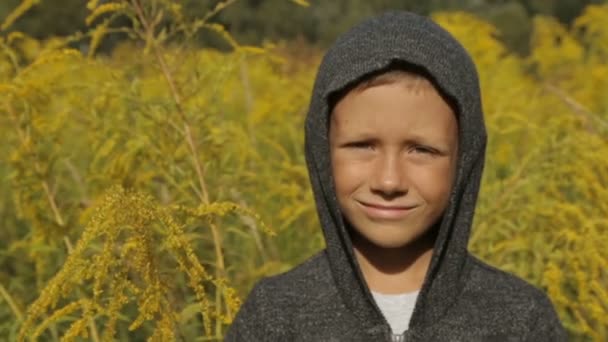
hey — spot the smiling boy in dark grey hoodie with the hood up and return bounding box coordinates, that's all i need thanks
[226,12,566,341]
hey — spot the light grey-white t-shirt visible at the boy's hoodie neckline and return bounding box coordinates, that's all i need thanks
[372,291,420,335]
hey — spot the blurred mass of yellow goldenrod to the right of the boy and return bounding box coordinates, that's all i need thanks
[436,5,608,341]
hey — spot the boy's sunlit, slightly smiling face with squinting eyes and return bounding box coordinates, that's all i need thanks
[329,81,458,248]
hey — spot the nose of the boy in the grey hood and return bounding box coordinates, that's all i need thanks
[370,155,408,200]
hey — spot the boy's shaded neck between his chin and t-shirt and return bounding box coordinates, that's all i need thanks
[353,230,434,294]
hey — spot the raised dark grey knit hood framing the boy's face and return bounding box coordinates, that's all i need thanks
[305,12,486,336]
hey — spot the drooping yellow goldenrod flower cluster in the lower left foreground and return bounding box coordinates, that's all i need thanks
[20,187,245,340]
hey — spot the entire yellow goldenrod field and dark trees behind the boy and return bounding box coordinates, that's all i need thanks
[0,0,608,341]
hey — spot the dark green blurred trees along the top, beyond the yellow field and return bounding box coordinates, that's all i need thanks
[0,0,606,54]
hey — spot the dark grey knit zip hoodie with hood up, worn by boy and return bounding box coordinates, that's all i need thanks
[226,12,566,341]
